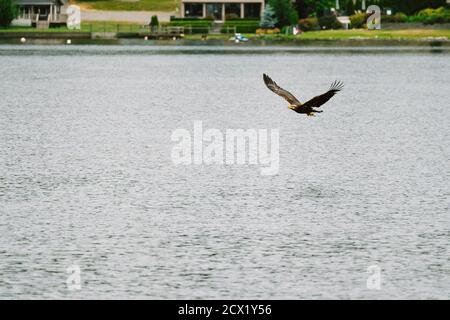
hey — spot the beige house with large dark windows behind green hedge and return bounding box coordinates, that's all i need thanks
[181,0,265,21]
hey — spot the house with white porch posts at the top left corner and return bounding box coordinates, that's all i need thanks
[13,0,69,28]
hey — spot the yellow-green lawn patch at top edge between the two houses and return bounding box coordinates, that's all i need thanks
[73,0,179,11]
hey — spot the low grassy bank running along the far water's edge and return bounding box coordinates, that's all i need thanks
[0,28,450,45]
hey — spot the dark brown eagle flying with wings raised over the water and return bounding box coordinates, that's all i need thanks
[263,74,344,116]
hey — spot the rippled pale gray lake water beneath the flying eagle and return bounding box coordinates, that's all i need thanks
[0,45,450,299]
